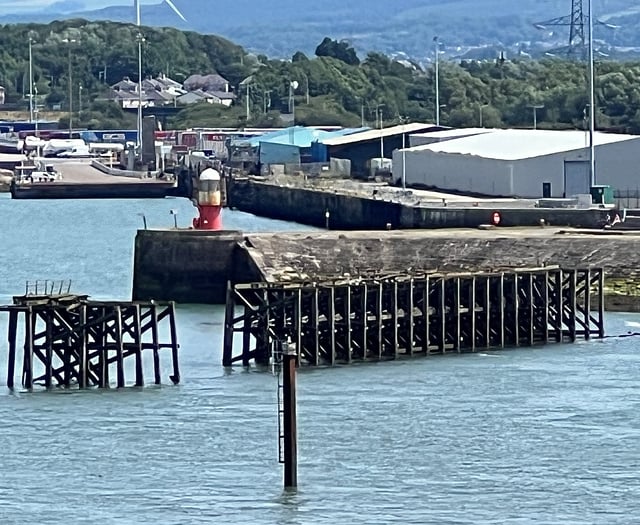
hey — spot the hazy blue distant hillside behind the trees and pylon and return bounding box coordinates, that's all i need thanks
[0,0,640,59]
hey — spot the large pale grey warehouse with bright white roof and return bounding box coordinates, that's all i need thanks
[393,130,640,198]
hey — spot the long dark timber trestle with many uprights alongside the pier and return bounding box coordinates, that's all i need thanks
[223,267,604,366]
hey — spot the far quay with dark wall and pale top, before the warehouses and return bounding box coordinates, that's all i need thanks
[227,178,612,230]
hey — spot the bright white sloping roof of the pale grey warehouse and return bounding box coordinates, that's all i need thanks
[410,129,640,160]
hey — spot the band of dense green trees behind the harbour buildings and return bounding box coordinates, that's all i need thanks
[0,20,640,133]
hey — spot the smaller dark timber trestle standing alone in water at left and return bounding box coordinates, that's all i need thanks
[0,284,180,389]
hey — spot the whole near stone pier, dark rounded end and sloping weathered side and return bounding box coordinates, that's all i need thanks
[133,228,640,304]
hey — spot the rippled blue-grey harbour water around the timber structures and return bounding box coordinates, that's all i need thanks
[0,195,640,525]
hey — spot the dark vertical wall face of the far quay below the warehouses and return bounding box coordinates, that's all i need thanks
[227,179,611,230]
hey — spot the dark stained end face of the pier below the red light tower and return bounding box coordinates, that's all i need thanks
[132,230,248,304]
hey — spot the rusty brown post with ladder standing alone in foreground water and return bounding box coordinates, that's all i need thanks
[282,343,298,488]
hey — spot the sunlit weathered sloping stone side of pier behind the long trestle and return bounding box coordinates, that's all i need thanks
[239,228,640,281]
